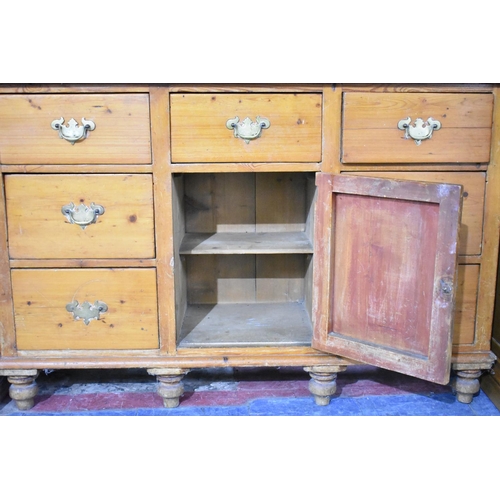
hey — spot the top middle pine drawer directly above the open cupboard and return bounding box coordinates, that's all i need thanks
[170,93,321,163]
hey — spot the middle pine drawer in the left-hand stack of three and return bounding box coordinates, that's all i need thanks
[5,174,155,259]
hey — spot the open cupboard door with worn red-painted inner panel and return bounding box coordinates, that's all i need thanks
[312,173,462,384]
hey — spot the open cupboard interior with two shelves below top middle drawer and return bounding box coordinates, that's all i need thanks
[172,172,316,347]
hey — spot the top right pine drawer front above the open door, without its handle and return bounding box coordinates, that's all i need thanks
[342,92,493,163]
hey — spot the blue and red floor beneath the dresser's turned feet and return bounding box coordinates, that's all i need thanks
[0,366,500,416]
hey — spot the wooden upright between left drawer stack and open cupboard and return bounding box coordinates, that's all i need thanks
[150,87,176,354]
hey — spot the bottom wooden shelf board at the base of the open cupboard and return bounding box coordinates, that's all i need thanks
[179,302,312,347]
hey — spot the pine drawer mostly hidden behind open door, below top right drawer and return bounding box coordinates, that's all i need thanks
[349,172,486,255]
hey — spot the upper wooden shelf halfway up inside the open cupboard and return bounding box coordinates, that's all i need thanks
[180,231,313,255]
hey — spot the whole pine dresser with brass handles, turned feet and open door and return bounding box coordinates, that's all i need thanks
[0,84,500,409]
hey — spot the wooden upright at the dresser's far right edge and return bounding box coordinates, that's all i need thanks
[475,85,500,351]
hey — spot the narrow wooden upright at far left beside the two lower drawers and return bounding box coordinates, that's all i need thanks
[0,172,17,356]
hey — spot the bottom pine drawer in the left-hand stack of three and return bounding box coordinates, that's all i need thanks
[12,269,159,350]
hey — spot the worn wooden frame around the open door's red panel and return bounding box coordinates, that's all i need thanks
[312,173,462,384]
